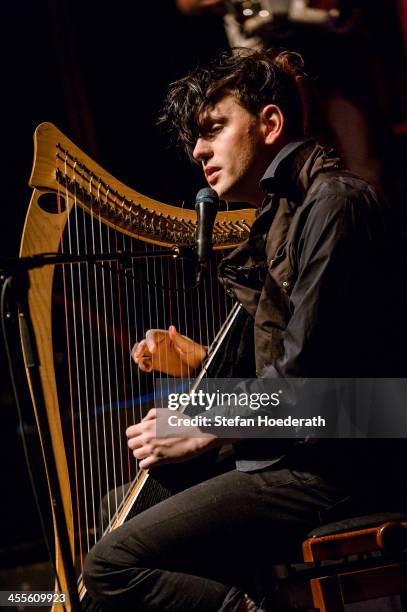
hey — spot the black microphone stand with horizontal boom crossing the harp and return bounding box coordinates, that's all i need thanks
[0,247,188,612]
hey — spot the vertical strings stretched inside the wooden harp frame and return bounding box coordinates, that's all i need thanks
[58,153,237,567]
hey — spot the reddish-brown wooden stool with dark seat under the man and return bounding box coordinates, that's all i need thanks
[302,512,407,612]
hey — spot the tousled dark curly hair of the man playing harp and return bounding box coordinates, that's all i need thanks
[158,48,305,158]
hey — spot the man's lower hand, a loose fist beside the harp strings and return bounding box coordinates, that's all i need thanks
[126,408,223,470]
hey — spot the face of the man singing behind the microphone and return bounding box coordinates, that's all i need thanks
[193,94,271,206]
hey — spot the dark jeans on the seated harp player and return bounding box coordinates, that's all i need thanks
[84,468,364,612]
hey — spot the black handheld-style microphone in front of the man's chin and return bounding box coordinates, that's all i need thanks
[195,187,219,284]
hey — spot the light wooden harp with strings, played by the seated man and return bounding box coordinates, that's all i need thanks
[20,123,254,608]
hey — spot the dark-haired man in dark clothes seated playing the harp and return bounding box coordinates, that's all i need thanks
[84,50,402,612]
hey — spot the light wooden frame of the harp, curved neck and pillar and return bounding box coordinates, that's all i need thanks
[20,123,254,609]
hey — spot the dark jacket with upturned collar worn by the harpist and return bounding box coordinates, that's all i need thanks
[219,141,407,475]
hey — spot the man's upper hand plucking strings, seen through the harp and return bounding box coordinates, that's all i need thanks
[131,325,207,377]
